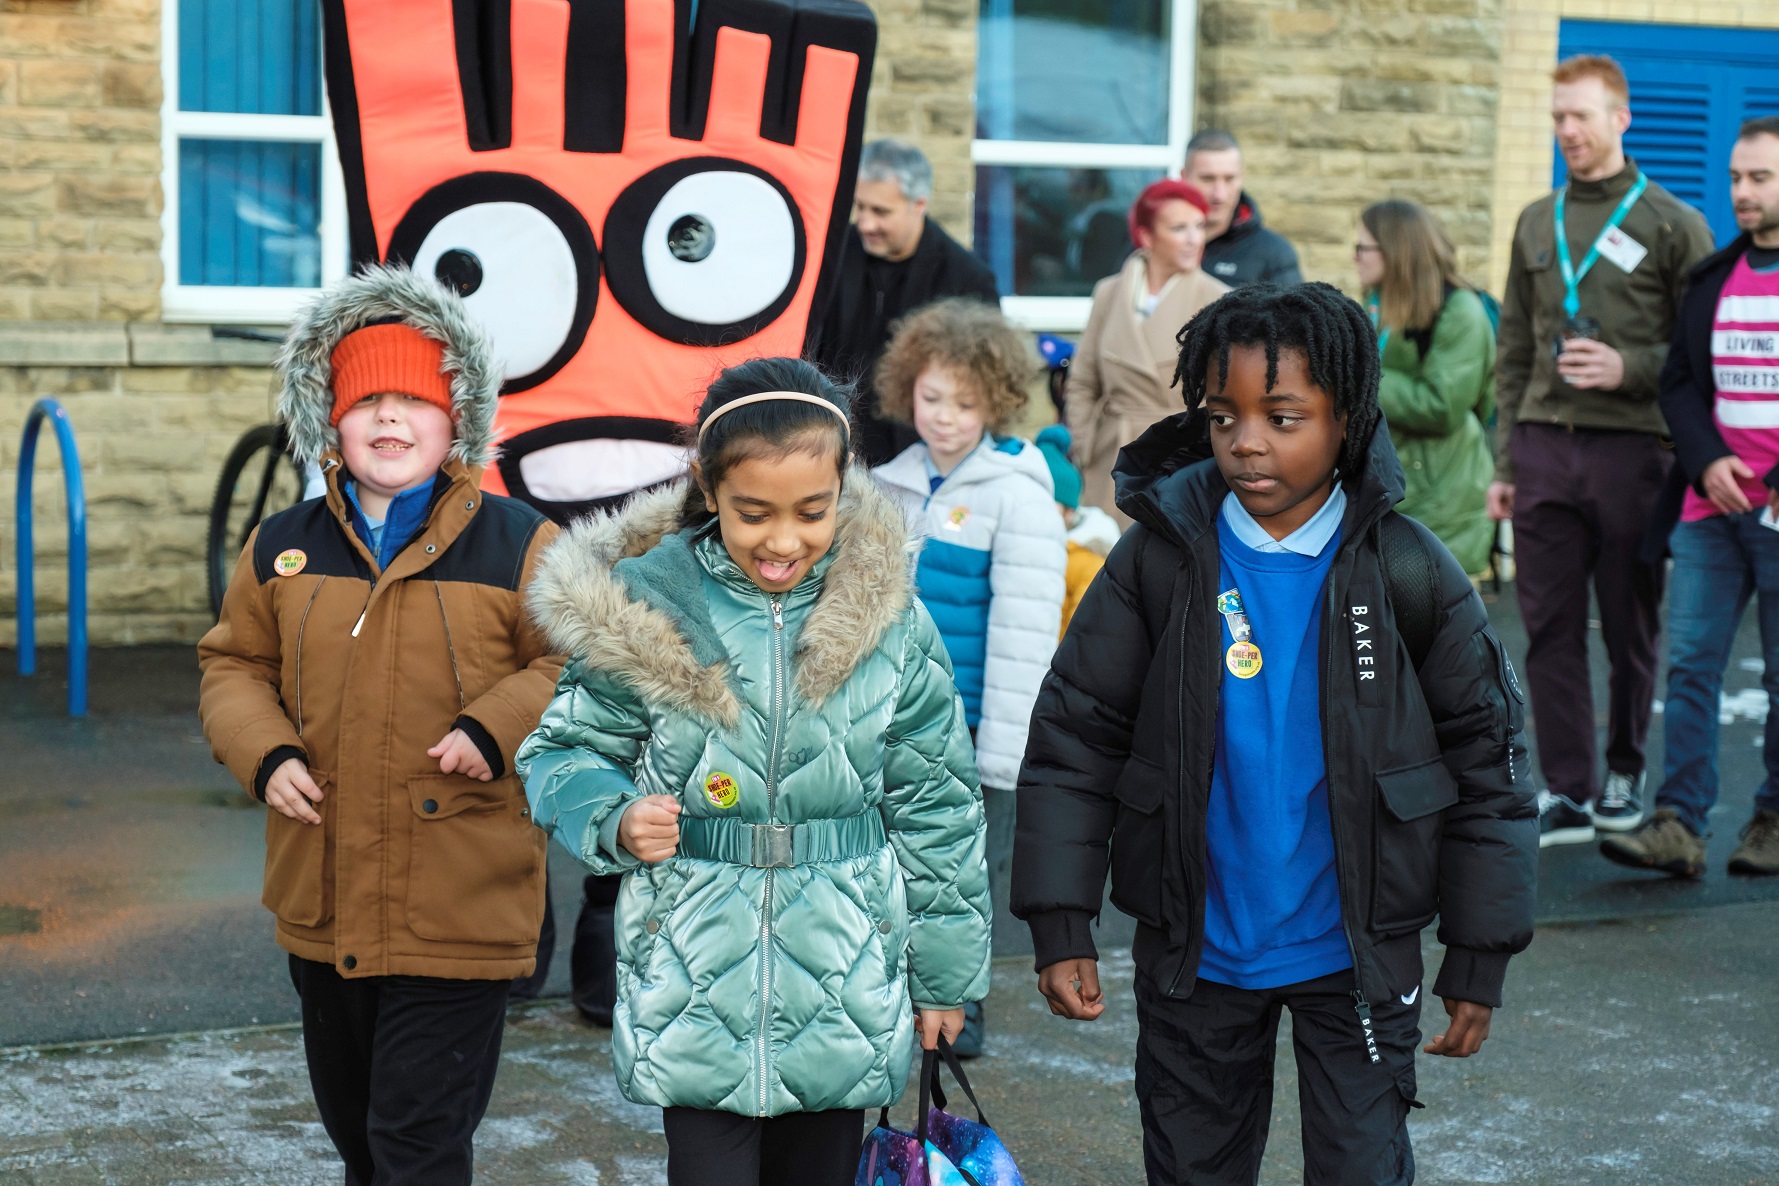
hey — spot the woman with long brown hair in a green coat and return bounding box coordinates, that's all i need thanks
[1352,199,1494,574]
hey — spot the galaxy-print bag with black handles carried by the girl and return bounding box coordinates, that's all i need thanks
[854,1037,1025,1186]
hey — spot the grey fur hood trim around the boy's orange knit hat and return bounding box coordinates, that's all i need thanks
[278,267,502,466]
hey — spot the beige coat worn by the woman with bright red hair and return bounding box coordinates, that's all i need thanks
[1066,251,1229,528]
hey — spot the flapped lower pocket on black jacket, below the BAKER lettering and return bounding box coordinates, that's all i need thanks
[1372,757,1459,935]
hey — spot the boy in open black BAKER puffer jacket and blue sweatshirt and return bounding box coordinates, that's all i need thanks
[1012,284,1537,1184]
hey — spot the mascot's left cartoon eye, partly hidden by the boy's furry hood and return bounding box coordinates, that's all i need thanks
[388,172,600,395]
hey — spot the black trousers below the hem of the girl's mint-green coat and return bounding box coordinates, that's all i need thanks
[662,1108,865,1186]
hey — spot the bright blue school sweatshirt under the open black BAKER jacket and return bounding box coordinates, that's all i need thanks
[1199,485,1352,989]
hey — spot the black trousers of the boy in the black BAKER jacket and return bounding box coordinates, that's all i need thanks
[1137,969,1421,1186]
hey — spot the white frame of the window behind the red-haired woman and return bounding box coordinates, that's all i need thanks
[970,0,1199,333]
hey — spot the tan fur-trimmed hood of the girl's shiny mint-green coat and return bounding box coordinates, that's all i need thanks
[528,468,913,729]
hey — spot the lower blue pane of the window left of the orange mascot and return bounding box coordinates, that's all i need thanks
[180,140,322,288]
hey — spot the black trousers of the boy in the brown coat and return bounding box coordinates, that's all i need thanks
[290,955,511,1186]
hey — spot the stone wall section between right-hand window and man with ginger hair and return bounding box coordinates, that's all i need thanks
[1197,0,1501,290]
